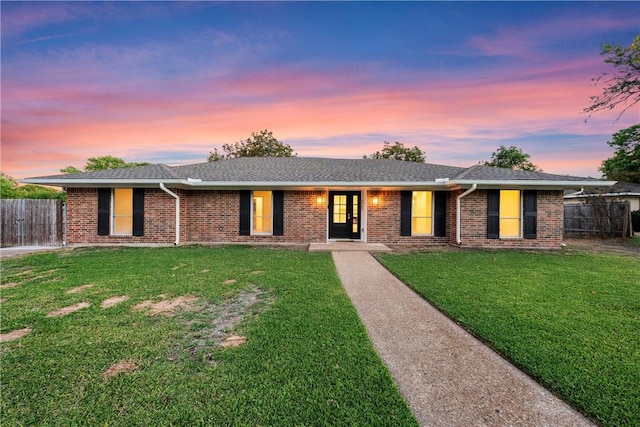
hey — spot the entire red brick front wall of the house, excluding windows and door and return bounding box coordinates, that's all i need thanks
[66,188,564,248]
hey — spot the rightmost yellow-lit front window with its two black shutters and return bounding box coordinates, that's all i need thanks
[487,190,538,239]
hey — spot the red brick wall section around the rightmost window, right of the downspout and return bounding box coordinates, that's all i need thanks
[452,190,564,249]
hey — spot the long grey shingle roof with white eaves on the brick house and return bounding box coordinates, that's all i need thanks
[21,157,613,188]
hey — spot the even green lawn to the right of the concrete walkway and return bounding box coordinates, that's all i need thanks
[379,251,640,426]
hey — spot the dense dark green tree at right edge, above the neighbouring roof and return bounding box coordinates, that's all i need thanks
[600,123,640,183]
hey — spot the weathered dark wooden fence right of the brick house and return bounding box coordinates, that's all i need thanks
[564,198,631,237]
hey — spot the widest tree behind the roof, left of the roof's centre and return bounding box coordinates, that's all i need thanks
[207,129,296,162]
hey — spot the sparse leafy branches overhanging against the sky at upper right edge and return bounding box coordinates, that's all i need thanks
[583,35,640,118]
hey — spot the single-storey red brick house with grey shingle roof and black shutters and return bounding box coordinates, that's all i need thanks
[22,157,613,248]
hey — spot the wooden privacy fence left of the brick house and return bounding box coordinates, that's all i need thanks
[0,199,64,247]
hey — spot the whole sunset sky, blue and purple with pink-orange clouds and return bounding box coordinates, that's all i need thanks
[1,1,640,179]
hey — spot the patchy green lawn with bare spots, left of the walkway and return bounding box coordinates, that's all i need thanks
[0,247,416,426]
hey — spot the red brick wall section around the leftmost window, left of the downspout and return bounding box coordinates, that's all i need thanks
[66,188,176,244]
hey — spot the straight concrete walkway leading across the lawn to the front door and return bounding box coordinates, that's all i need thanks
[332,251,593,427]
